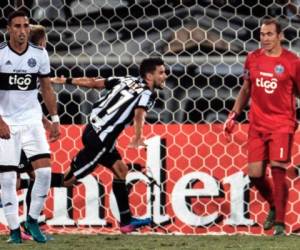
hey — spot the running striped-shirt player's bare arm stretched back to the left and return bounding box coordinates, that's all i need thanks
[51,76,105,89]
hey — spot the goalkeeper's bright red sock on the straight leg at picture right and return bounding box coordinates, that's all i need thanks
[271,166,288,223]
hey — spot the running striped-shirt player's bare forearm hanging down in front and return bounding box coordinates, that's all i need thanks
[128,108,146,148]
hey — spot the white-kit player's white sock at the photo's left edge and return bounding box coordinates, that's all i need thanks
[0,171,20,230]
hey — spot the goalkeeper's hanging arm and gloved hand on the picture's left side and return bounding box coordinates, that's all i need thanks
[224,80,250,140]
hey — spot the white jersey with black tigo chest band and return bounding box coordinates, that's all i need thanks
[0,43,50,125]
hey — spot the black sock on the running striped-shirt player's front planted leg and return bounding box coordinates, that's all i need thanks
[112,179,131,225]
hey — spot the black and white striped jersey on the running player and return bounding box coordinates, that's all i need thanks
[90,76,155,143]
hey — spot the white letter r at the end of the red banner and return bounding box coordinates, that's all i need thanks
[223,172,254,225]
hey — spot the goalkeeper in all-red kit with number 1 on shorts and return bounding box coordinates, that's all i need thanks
[224,19,300,235]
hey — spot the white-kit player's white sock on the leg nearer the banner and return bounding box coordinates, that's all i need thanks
[29,167,51,219]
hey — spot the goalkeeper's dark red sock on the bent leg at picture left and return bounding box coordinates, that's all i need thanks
[250,176,274,209]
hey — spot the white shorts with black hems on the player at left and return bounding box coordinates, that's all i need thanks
[0,122,50,171]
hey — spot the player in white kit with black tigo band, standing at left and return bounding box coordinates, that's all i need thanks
[0,11,60,243]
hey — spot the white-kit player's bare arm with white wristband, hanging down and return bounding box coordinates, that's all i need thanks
[40,77,60,142]
